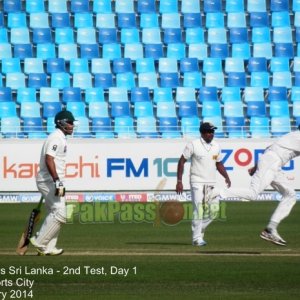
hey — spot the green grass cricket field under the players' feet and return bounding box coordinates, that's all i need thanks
[0,202,300,300]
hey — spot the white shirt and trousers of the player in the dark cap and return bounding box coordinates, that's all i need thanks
[183,137,221,241]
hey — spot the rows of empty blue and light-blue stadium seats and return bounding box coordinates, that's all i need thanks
[0,0,300,138]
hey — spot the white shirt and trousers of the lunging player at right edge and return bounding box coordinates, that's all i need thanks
[220,131,300,224]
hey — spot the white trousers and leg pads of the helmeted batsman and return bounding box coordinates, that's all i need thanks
[36,182,66,252]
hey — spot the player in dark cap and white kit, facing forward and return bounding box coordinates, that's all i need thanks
[176,122,231,247]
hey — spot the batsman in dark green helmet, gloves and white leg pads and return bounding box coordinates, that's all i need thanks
[30,111,75,255]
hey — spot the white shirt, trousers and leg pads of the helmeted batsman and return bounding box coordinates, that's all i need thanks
[36,129,67,252]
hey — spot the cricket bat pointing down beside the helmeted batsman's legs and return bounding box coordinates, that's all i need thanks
[16,197,43,255]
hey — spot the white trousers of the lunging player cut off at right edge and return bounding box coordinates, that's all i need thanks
[220,150,296,224]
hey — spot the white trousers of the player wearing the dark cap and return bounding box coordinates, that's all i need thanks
[191,183,219,241]
